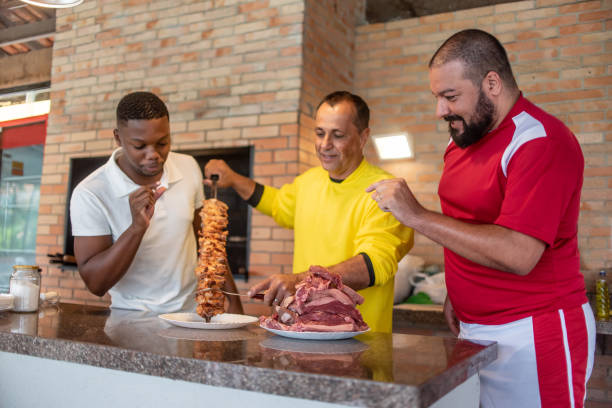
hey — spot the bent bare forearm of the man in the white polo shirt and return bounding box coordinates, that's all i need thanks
[75,227,144,296]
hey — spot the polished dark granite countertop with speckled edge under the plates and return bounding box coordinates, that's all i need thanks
[0,304,497,407]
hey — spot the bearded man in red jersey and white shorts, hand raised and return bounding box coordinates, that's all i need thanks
[367,30,595,407]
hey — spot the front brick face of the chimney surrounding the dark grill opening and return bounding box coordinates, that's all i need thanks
[37,0,304,304]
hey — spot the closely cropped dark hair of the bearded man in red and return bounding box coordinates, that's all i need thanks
[429,29,517,89]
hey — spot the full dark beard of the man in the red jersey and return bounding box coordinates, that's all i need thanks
[444,89,495,149]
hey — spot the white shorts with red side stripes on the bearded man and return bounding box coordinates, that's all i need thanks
[459,303,595,408]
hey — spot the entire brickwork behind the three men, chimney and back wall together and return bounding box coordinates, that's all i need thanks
[37,0,612,310]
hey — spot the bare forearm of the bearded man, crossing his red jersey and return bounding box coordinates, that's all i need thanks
[411,211,546,275]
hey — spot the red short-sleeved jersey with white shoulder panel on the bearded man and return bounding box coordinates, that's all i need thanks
[438,95,587,324]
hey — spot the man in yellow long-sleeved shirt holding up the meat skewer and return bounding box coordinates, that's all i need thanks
[205,91,413,332]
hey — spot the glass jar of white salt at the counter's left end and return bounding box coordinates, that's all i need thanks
[9,265,40,312]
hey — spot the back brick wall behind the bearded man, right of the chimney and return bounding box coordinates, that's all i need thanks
[355,0,612,288]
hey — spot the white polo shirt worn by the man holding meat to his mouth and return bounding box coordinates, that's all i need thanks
[70,148,204,313]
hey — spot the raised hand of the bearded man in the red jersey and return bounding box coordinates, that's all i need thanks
[366,178,426,227]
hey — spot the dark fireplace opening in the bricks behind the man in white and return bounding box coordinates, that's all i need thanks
[63,146,253,282]
